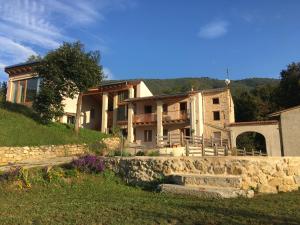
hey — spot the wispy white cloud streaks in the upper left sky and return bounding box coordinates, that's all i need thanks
[0,0,133,80]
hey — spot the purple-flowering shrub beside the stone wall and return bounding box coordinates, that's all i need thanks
[71,155,105,173]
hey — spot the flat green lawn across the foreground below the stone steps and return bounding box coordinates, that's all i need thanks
[0,169,300,225]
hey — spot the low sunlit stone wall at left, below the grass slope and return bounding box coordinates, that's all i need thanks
[0,145,88,165]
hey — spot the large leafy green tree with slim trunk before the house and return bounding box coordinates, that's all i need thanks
[34,41,104,133]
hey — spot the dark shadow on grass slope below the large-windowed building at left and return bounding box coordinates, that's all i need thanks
[0,102,42,123]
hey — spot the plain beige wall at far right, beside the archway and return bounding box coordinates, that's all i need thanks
[280,108,300,156]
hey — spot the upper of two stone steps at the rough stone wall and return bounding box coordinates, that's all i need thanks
[170,174,242,188]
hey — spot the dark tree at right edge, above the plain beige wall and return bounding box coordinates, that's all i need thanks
[276,63,300,108]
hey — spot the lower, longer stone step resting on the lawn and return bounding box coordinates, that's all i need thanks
[159,184,254,198]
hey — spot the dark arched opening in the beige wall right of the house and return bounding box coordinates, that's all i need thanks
[236,132,267,154]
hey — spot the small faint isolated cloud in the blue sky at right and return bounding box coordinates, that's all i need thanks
[198,21,229,39]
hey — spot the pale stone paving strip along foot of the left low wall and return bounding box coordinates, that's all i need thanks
[0,156,77,171]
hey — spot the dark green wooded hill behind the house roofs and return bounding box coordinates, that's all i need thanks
[142,77,279,95]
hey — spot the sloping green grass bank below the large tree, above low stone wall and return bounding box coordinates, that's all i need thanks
[0,103,103,146]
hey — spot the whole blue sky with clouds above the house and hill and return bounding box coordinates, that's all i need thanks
[0,0,300,80]
